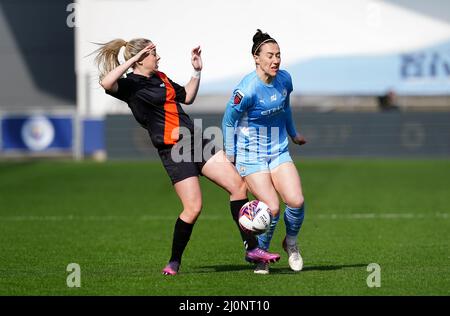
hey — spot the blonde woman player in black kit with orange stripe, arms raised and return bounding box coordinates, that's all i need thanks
[96,38,280,275]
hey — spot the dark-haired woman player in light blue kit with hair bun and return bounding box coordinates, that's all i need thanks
[222,29,306,274]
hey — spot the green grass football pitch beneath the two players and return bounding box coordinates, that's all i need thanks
[0,159,450,296]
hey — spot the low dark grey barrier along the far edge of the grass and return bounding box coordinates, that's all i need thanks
[105,112,450,159]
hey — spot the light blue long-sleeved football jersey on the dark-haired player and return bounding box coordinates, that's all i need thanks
[222,70,297,159]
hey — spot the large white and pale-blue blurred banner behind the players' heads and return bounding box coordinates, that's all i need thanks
[75,0,450,115]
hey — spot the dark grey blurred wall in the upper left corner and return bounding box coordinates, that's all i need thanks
[0,0,76,109]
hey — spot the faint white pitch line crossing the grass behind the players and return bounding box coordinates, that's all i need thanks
[0,213,450,222]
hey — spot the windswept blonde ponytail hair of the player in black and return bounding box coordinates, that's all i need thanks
[94,38,151,81]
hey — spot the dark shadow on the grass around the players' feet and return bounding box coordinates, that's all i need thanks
[192,263,367,274]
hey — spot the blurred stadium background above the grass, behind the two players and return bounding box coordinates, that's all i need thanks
[0,0,450,159]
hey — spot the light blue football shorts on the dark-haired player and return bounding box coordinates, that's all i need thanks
[236,151,292,177]
